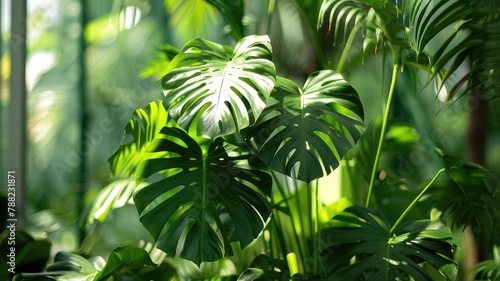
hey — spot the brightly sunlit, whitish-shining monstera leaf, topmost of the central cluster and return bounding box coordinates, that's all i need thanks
[162,36,276,139]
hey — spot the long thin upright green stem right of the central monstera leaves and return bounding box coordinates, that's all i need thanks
[365,63,399,208]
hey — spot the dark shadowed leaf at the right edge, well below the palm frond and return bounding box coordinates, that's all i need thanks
[436,152,500,239]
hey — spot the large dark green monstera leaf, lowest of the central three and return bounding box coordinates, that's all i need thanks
[134,127,272,264]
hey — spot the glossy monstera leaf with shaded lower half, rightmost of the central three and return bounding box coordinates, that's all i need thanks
[244,70,363,182]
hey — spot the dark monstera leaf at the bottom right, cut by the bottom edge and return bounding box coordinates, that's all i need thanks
[320,206,457,280]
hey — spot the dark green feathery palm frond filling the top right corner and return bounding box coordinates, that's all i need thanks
[409,0,500,109]
